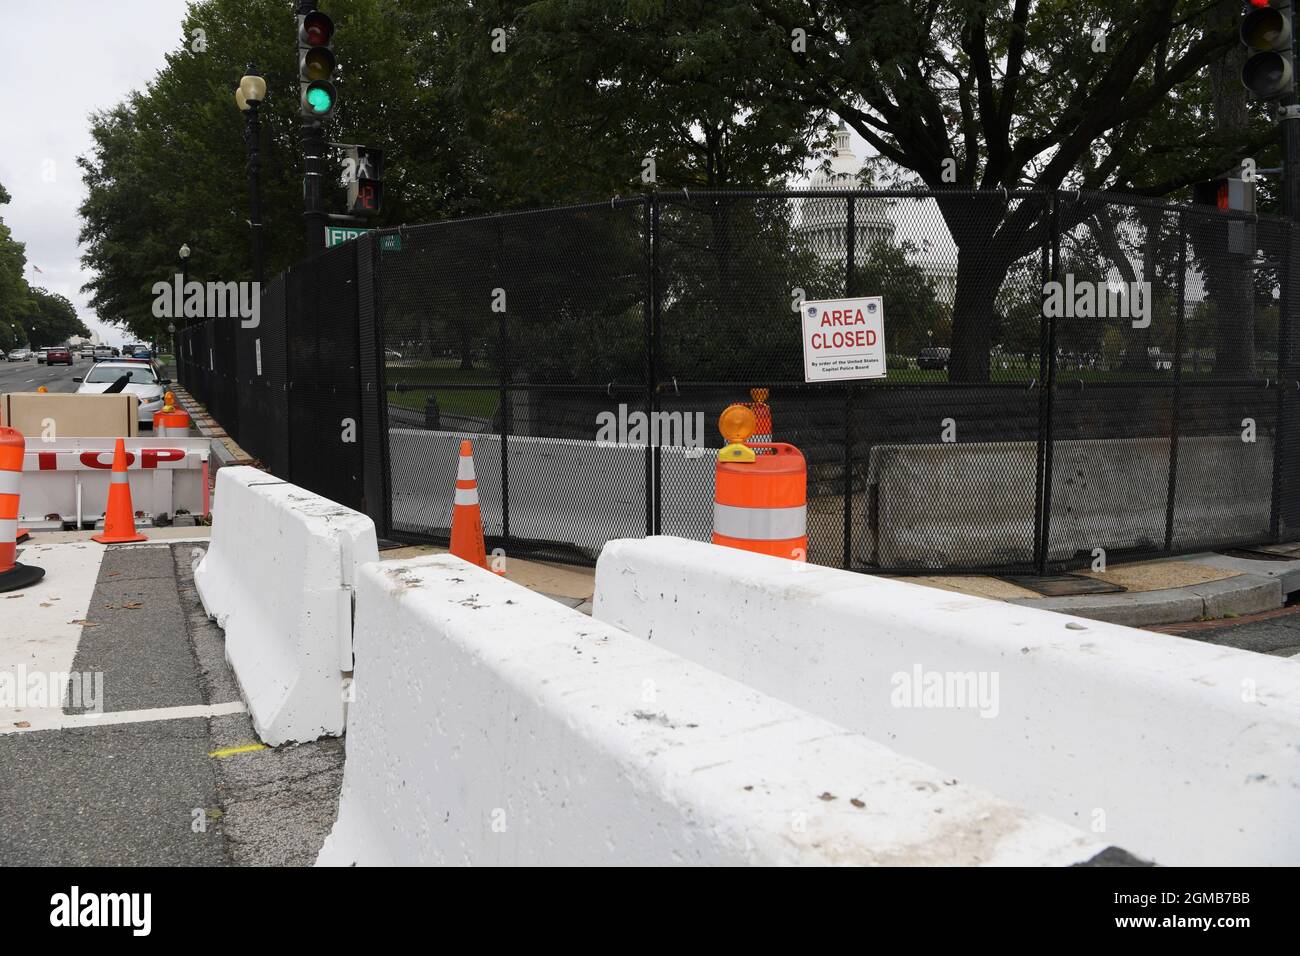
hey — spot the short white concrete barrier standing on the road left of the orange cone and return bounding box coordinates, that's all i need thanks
[194,466,380,745]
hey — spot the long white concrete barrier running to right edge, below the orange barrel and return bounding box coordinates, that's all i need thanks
[593,537,1300,865]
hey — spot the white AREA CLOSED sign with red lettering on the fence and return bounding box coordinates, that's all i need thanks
[800,295,887,381]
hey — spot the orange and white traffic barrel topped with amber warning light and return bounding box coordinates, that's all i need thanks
[712,405,807,561]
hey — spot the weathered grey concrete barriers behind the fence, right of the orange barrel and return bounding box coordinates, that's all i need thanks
[859,436,1273,567]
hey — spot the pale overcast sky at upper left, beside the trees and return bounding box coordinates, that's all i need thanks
[0,0,187,346]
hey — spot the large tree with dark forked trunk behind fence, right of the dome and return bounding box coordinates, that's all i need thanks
[732,0,1275,381]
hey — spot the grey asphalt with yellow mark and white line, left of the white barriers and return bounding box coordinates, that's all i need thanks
[0,542,343,866]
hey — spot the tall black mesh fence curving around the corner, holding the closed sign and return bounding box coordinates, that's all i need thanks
[179,191,1300,572]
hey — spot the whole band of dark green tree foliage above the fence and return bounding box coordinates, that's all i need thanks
[82,0,1277,381]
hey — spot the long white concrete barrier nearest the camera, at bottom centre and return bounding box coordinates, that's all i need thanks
[319,555,1128,865]
